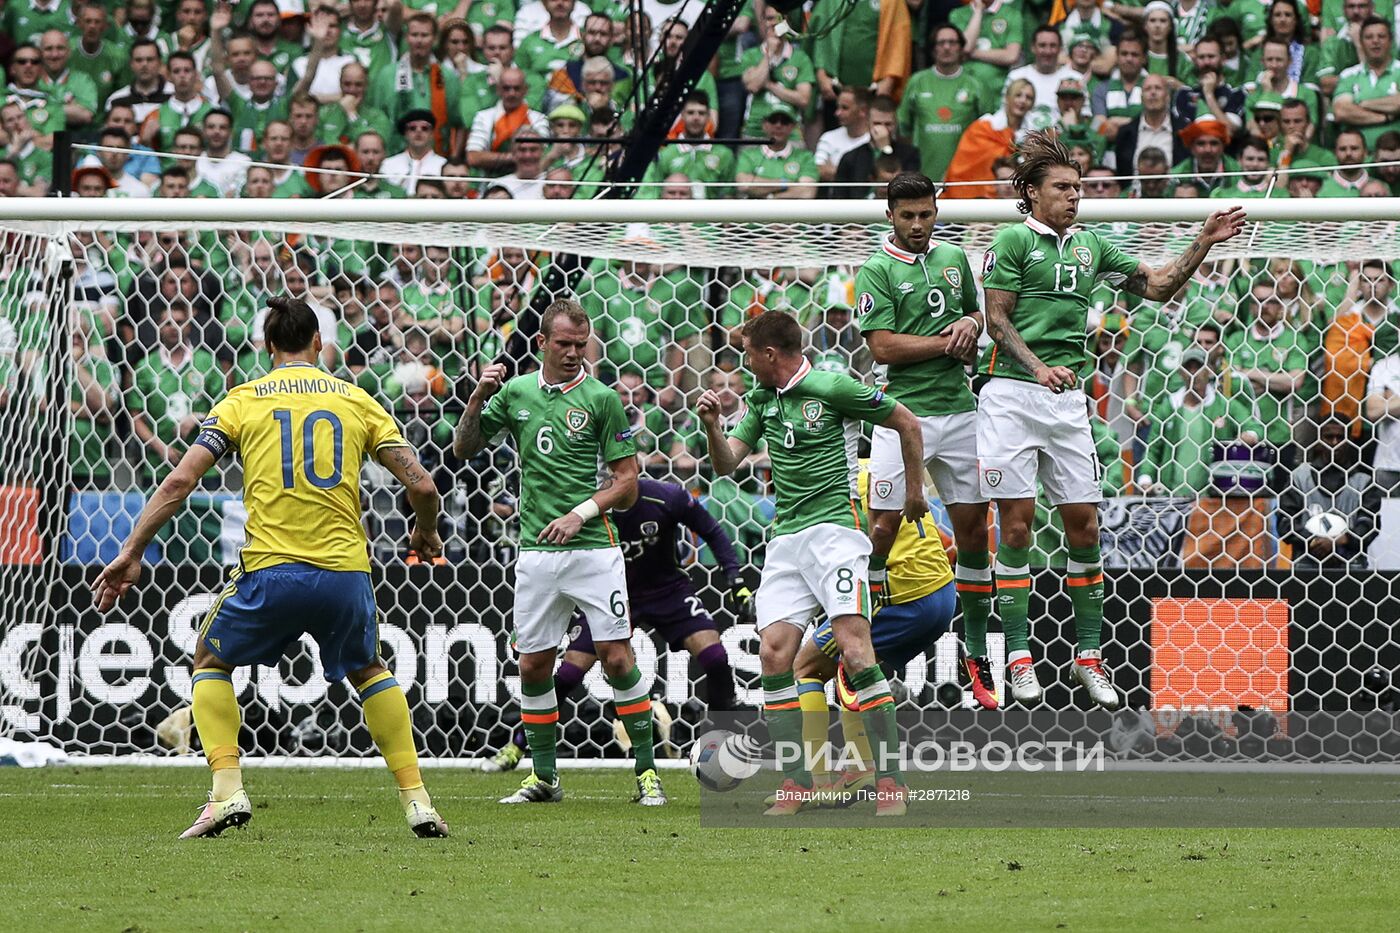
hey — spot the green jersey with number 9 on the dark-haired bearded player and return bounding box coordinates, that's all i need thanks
[855,235,977,416]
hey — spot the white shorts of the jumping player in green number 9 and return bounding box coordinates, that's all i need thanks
[871,412,987,510]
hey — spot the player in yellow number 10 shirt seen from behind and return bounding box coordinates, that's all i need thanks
[92,297,447,839]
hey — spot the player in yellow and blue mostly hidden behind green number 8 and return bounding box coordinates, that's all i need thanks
[792,461,958,815]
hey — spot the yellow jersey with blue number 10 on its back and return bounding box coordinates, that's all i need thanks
[196,363,407,573]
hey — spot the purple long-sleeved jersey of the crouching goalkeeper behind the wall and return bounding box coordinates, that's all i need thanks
[609,479,739,602]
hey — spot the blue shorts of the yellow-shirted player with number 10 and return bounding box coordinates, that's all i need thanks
[202,563,379,684]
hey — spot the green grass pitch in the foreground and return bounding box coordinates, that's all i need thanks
[0,766,1400,933]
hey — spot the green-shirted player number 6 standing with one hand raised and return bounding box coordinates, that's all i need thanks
[452,301,666,807]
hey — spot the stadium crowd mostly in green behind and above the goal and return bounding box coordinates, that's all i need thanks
[0,0,1400,567]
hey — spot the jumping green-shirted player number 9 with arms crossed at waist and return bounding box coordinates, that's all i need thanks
[855,172,998,709]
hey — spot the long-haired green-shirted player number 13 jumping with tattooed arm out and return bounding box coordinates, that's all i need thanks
[977,132,1245,709]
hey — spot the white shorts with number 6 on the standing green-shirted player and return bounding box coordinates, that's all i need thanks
[514,548,631,654]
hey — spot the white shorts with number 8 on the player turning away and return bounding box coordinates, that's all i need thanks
[753,524,871,632]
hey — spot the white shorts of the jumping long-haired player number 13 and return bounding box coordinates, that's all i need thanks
[977,378,1103,506]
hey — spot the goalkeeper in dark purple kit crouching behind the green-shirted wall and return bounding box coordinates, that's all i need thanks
[482,478,753,770]
